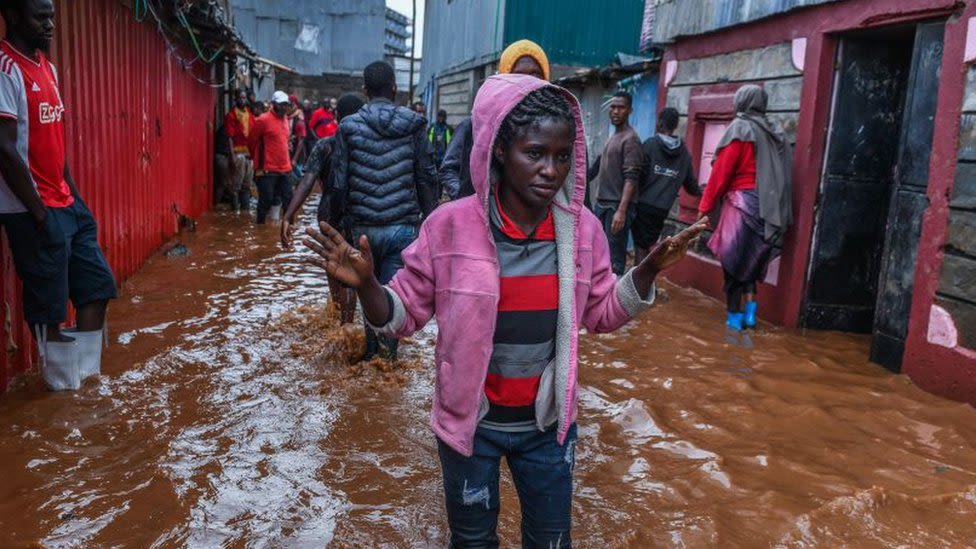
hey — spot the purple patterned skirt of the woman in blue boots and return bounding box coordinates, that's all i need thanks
[708,191,781,282]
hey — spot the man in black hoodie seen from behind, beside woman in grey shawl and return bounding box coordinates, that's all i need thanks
[631,107,701,265]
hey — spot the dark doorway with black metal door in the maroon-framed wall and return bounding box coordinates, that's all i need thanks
[802,22,944,371]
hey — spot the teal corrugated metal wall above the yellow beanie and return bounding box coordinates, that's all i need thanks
[504,0,644,67]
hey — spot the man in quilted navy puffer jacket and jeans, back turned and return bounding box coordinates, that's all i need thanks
[332,61,438,360]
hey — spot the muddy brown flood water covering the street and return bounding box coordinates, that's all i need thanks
[0,199,976,549]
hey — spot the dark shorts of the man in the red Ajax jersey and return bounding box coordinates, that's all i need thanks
[0,199,116,324]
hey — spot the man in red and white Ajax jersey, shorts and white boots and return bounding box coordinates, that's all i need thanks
[0,0,116,390]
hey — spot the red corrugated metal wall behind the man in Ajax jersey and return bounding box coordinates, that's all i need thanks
[0,0,215,390]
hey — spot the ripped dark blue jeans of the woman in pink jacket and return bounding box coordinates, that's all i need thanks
[437,425,576,549]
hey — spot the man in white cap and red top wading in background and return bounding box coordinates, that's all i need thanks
[249,90,292,224]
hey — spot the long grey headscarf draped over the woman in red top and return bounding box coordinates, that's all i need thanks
[715,84,793,245]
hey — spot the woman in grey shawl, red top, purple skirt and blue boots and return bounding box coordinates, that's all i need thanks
[699,84,793,330]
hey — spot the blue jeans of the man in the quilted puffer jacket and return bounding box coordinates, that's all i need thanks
[352,225,417,360]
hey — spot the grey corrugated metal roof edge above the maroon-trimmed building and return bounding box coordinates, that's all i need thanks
[654,0,843,44]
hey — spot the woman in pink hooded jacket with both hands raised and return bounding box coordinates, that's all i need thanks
[305,74,704,547]
